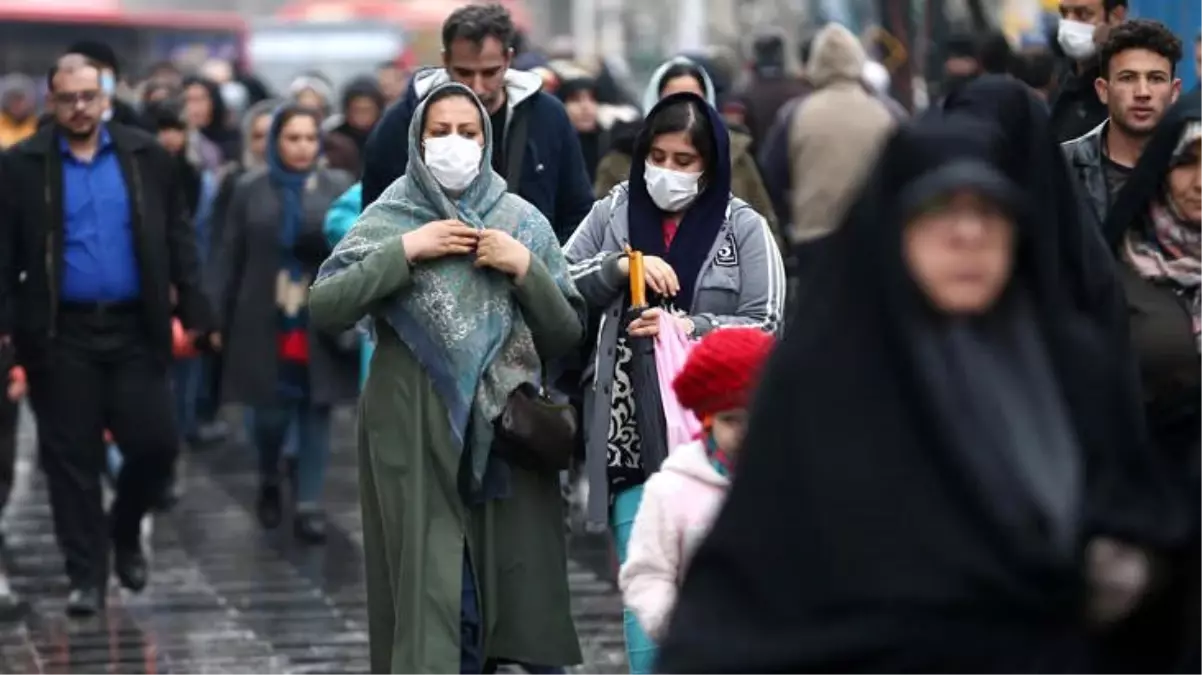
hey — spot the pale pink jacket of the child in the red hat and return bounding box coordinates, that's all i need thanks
[618,441,730,641]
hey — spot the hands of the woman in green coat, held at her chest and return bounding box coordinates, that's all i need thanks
[401,220,530,280]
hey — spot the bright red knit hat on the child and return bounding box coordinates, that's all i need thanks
[672,328,775,419]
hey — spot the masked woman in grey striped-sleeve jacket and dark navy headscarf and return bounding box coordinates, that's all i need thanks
[564,92,785,674]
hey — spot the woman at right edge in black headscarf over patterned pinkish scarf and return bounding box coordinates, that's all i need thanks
[1099,94,1202,675]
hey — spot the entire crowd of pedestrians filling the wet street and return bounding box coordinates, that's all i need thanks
[0,0,1202,675]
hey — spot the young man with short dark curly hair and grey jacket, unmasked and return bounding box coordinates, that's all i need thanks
[1064,19,1182,225]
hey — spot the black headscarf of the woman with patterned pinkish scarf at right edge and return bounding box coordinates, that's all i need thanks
[1102,91,1202,251]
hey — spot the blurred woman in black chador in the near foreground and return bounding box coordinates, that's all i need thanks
[660,117,1173,675]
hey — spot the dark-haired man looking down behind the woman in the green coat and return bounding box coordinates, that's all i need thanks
[363,4,594,243]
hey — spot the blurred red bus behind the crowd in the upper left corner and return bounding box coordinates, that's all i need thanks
[0,0,249,78]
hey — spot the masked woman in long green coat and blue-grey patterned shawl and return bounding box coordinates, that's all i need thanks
[309,83,584,675]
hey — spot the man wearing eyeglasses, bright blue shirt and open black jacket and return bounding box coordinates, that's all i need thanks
[0,54,216,616]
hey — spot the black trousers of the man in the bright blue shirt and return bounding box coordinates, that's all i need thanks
[28,307,179,587]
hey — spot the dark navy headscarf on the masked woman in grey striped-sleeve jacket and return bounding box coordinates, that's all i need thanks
[626,92,731,311]
